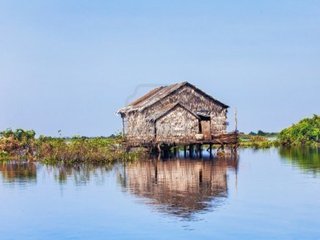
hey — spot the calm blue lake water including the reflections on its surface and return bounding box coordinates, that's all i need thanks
[0,148,320,240]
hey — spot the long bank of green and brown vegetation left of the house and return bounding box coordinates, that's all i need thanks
[0,129,142,164]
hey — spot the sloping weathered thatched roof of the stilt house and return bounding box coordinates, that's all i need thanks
[118,82,229,113]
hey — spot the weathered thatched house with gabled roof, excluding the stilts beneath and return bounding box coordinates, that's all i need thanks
[118,82,232,145]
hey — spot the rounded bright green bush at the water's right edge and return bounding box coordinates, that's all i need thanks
[279,115,320,147]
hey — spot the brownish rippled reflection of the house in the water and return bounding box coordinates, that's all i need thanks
[119,158,238,218]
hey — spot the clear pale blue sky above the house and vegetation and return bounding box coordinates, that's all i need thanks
[0,0,320,136]
